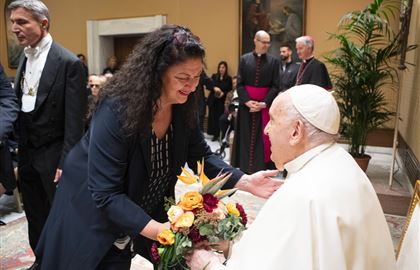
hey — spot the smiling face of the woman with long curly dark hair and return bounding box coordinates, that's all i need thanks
[161,58,203,104]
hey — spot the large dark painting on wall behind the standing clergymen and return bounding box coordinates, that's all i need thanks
[239,0,305,56]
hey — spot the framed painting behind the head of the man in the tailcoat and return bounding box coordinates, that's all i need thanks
[4,0,23,68]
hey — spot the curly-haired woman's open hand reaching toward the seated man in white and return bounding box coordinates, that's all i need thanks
[235,170,284,199]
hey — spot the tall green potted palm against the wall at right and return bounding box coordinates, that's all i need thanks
[326,0,414,170]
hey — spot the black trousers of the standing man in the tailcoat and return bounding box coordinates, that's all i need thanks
[19,160,55,250]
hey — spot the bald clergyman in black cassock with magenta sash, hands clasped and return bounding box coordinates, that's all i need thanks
[231,30,279,173]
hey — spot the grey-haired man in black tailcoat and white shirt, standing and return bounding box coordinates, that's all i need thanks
[8,0,87,258]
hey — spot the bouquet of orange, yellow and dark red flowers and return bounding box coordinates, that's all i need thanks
[152,161,247,270]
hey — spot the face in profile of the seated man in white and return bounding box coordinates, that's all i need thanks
[264,93,295,169]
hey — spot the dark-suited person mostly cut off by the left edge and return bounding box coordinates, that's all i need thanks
[0,64,19,210]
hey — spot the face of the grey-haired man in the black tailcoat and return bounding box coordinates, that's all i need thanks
[10,8,48,47]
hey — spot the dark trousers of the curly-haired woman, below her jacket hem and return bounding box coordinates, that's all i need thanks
[96,245,132,270]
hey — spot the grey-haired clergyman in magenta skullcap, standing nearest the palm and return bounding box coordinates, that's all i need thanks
[295,36,332,90]
